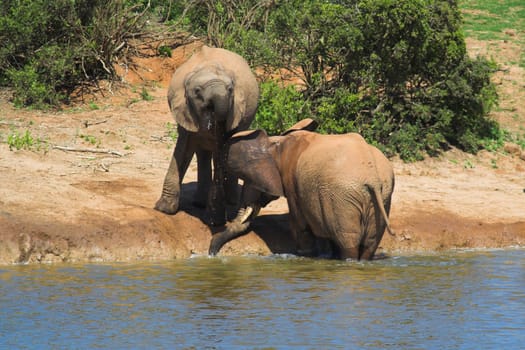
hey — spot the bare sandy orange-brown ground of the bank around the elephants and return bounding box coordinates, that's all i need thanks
[0,41,525,264]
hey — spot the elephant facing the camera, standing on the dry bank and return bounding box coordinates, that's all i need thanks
[155,46,259,226]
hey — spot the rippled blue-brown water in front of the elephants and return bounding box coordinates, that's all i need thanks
[0,250,525,349]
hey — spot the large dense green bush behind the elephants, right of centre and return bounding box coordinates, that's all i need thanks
[183,0,498,160]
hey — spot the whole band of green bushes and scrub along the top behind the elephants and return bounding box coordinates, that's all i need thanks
[0,0,524,160]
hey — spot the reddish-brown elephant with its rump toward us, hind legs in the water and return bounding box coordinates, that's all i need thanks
[209,119,394,260]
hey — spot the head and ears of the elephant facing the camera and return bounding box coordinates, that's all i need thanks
[168,46,259,137]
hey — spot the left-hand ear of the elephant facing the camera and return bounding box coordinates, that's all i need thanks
[168,72,199,132]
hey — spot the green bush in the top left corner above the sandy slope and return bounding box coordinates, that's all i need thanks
[0,0,148,108]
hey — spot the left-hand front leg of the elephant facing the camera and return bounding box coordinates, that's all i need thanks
[155,127,194,215]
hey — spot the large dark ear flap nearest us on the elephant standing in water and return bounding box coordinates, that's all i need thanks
[228,130,284,197]
